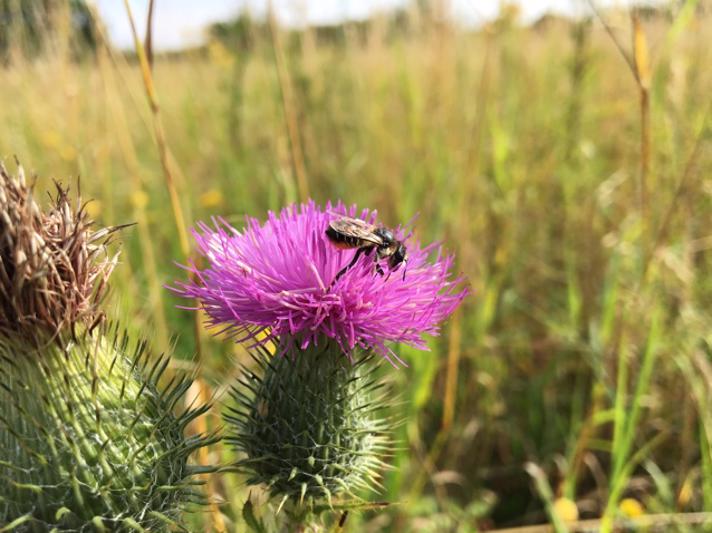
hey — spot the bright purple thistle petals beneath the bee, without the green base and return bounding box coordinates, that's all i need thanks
[171,201,467,363]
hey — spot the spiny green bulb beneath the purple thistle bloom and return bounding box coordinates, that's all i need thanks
[225,344,392,507]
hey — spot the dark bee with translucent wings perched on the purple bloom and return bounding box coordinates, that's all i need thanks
[326,217,408,284]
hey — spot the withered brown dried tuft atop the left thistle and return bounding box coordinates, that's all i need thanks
[0,164,118,343]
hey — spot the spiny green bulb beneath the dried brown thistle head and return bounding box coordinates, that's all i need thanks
[0,328,217,531]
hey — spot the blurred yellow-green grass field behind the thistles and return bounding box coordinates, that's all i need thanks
[0,1,712,532]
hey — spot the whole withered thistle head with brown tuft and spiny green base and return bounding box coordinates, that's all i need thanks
[0,166,212,532]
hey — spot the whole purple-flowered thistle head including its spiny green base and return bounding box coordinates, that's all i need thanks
[172,202,465,517]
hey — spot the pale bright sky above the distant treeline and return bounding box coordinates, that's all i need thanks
[94,0,660,50]
